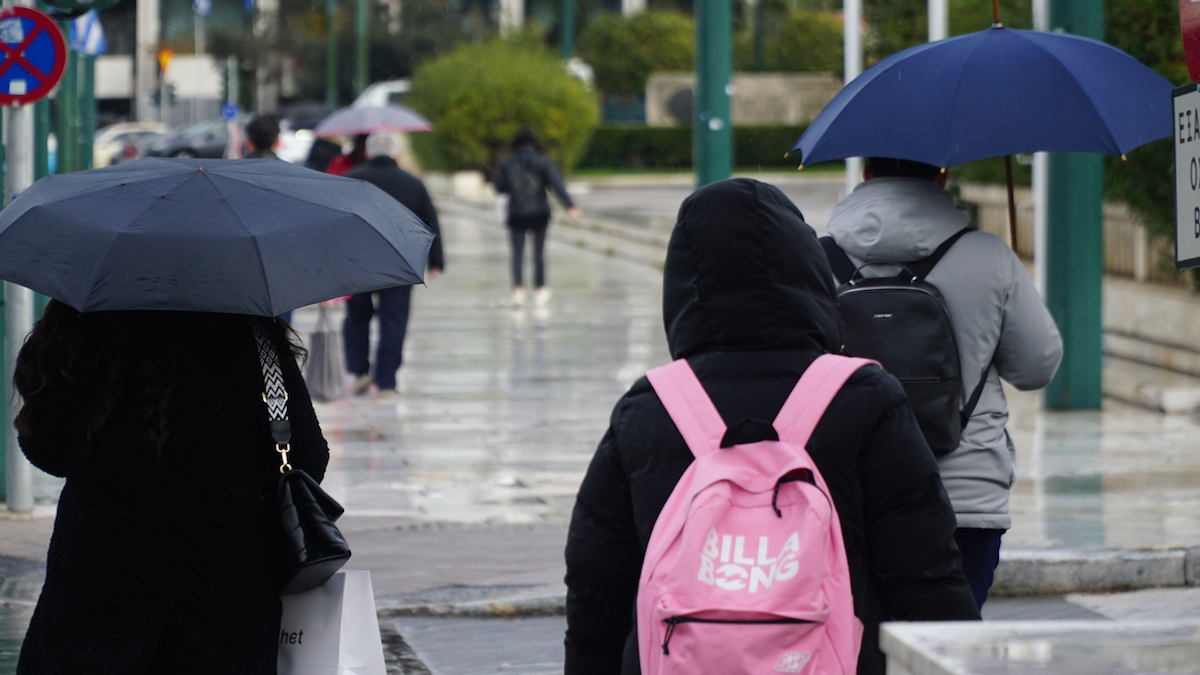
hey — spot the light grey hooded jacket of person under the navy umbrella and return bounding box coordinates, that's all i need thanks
[829,178,1062,530]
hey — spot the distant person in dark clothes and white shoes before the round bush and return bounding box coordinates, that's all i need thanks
[492,126,580,306]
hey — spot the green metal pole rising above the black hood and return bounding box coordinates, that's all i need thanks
[692,0,733,187]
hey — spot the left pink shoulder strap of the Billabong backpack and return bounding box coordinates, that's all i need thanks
[646,359,725,458]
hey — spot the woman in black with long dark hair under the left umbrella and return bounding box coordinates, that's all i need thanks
[13,300,329,675]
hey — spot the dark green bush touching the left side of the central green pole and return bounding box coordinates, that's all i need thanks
[578,11,696,96]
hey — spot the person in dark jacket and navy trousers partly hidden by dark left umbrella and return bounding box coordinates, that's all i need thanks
[342,133,445,398]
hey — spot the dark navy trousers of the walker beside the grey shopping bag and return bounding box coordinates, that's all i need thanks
[342,286,413,389]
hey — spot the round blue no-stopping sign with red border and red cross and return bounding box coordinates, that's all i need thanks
[0,7,67,107]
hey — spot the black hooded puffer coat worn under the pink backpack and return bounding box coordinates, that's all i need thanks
[565,179,979,675]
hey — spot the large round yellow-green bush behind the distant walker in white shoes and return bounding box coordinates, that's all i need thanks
[406,40,599,175]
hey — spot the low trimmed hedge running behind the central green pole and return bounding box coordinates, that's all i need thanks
[576,126,808,169]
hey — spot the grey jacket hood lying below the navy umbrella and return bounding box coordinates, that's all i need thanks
[829,178,967,263]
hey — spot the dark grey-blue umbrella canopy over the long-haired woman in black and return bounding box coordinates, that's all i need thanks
[0,159,433,316]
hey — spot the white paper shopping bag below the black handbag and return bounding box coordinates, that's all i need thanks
[278,569,386,675]
